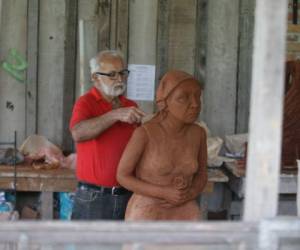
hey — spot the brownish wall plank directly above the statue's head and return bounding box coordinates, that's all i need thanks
[168,0,197,74]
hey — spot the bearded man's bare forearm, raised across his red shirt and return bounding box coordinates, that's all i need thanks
[71,111,117,142]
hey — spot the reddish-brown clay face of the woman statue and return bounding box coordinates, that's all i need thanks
[166,79,201,123]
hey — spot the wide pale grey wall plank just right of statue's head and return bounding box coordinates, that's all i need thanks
[202,0,239,136]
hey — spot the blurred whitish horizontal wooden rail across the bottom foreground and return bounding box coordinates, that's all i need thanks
[0,218,300,250]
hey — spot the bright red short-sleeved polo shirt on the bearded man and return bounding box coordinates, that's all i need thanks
[70,87,137,187]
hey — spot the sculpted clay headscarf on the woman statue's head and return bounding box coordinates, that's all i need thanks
[156,70,198,111]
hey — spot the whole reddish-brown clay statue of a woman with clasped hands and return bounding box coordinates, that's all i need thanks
[117,70,207,220]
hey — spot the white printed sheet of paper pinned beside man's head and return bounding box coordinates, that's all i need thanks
[127,64,155,101]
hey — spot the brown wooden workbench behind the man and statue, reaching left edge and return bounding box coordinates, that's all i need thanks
[0,165,228,219]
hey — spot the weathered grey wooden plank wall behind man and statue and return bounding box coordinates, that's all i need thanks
[0,0,254,150]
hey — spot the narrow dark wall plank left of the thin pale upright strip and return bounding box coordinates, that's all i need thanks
[62,0,78,151]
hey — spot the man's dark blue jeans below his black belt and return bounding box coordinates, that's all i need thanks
[72,185,131,220]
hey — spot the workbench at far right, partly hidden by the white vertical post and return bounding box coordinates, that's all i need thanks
[224,162,297,216]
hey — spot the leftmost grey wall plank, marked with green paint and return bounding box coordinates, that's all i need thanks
[0,0,27,145]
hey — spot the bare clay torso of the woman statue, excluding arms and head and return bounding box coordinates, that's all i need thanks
[126,121,202,220]
